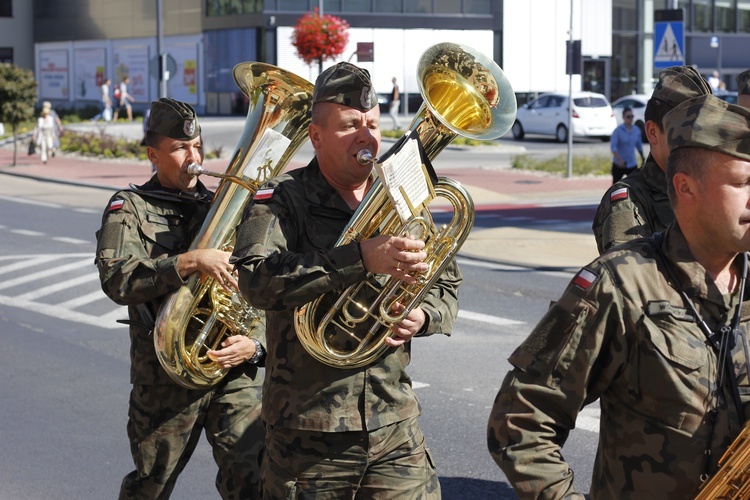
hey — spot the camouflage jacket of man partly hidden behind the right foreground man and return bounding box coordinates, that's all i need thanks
[592,155,674,255]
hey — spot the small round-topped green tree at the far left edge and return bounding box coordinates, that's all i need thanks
[0,63,37,167]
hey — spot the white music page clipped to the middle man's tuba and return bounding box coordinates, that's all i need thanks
[375,138,434,222]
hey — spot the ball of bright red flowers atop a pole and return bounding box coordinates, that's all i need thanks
[292,8,349,73]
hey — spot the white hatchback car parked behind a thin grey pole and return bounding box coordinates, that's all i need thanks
[511,92,617,142]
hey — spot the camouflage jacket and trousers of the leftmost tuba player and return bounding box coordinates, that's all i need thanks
[96,176,264,499]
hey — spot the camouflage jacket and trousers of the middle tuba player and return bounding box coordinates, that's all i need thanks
[233,159,461,498]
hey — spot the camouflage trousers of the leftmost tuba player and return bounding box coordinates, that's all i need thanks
[120,375,265,500]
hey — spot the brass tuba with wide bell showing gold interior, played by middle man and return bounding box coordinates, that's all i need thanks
[295,43,516,368]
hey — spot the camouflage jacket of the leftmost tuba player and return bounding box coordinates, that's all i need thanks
[95,175,257,385]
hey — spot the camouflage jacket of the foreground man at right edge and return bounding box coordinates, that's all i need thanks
[488,224,750,499]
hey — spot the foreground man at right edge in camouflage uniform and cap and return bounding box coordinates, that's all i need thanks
[487,95,750,499]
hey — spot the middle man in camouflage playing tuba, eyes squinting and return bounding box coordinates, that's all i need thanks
[232,63,461,498]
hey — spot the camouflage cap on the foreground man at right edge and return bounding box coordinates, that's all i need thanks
[664,95,750,161]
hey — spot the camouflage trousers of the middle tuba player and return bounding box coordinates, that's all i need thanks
[261,418,440,500]
